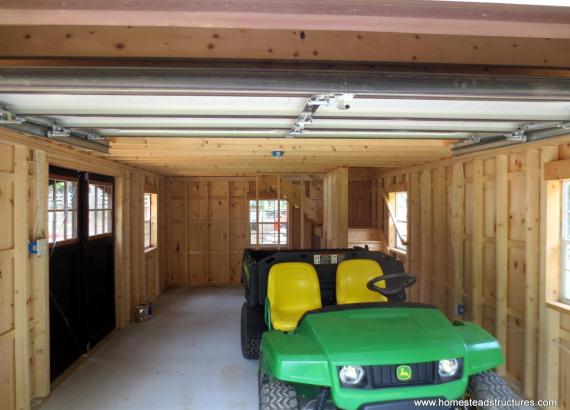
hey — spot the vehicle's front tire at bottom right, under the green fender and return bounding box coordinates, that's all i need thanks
[468,371,536,410]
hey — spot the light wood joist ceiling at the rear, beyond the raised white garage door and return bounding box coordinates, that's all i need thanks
[101,137,451,175]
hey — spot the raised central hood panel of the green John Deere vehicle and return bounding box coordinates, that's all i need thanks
[298,305,466,365]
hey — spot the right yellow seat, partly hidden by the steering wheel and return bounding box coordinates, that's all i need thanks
[336,259,388,305]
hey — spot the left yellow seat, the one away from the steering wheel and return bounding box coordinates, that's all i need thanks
[267,262,321,332]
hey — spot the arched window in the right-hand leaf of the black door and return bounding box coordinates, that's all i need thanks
[89,182,113,237]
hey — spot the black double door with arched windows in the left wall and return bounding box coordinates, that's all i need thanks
[48,167,115,381]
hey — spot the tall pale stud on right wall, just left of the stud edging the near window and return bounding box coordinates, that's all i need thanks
[523,149,540,398]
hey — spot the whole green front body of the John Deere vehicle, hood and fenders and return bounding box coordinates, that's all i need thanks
[261,304,504,396]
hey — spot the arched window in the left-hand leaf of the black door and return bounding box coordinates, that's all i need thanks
[48,178,77,244]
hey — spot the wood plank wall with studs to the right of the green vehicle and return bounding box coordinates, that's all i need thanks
[382,138,570,409]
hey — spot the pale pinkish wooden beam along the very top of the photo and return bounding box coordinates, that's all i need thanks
[0,0,570,38]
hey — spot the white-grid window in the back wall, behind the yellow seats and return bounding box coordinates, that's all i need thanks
[249,199,289,246]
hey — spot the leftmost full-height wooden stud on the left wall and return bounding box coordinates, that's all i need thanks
[13,145,32,410]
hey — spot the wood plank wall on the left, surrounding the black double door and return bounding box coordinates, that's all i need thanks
[0,130,166,410]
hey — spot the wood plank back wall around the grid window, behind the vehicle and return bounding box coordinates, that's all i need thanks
[164,175,322,286]
